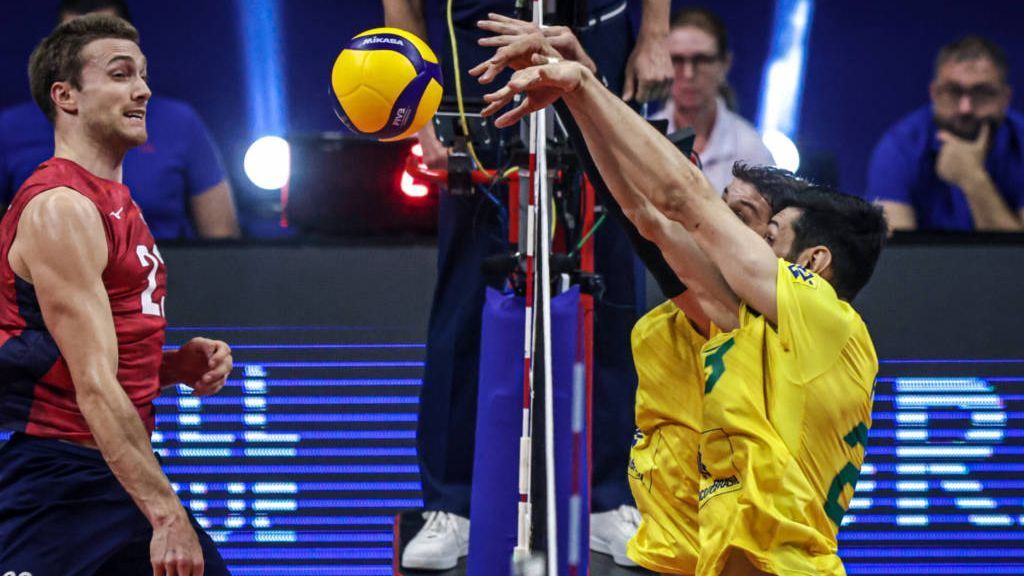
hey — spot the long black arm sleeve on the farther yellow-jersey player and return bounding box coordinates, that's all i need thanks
[555,100,686,299]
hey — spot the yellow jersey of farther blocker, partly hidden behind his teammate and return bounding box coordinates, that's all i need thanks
[627,301,707,574]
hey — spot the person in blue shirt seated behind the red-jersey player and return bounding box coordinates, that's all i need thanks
[0,0,239,240]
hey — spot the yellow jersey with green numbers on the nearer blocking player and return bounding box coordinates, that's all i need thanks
[696,259,879,576]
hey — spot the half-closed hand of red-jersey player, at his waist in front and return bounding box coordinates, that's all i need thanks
[163,338,233,396]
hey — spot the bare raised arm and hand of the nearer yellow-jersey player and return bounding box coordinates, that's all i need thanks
[485,54,777,322]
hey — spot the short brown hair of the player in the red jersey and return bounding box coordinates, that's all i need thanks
[29,14,138,122]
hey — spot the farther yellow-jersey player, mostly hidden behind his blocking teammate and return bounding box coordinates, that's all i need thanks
[628,163,809,575]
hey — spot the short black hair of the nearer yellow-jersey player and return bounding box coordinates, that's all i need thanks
[778,186,887,301]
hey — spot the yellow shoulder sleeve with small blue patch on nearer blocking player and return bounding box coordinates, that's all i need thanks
[775,259,860,380]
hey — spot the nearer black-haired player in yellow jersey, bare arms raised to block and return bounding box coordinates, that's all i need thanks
[475,39,886,575]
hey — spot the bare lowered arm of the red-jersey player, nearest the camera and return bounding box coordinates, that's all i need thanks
[8,189,203,576]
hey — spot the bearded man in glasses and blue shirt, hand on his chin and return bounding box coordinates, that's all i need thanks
[865,36,1024,232]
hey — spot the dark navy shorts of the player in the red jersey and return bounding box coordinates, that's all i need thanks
[0,434,228,576]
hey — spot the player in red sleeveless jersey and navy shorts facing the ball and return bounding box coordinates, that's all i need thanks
[0,14,231,576]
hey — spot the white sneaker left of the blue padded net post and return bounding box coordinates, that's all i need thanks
[401,510,469,570]
